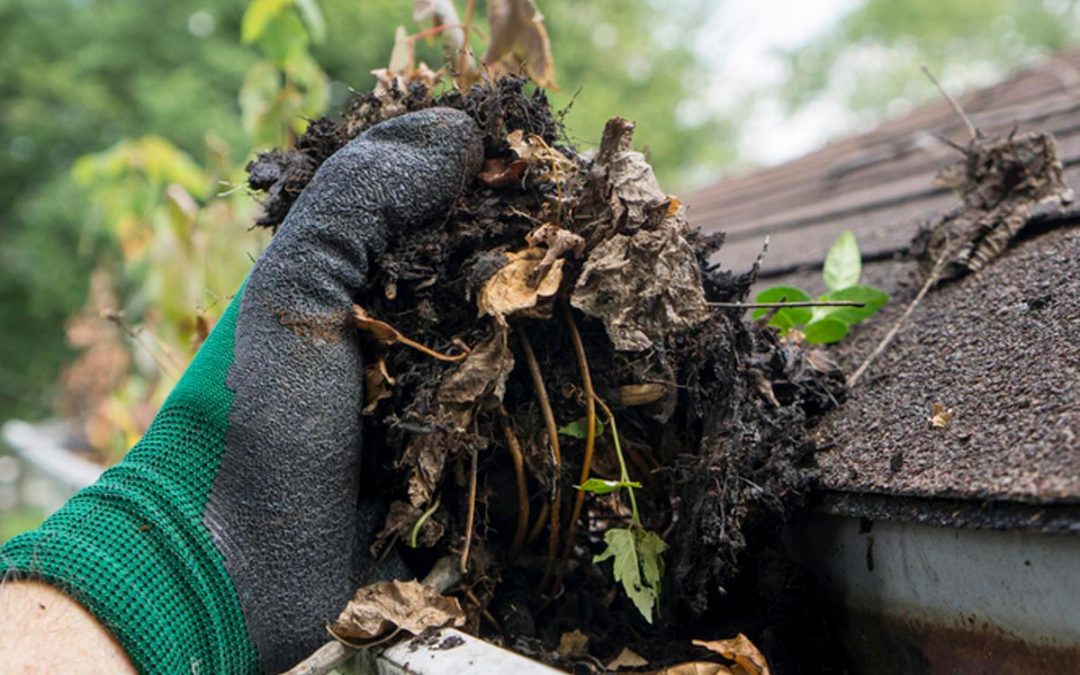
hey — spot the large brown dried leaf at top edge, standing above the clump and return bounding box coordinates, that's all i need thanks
[484,0,555,89]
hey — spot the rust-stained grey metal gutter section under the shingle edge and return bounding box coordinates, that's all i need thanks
[788,507,1080,674]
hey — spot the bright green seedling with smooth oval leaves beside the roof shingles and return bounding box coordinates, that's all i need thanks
[753,230,889,345]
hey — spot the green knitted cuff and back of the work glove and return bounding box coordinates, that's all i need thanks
[0,289,258,673]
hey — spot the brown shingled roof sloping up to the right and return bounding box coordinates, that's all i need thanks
[686,50,1080,503]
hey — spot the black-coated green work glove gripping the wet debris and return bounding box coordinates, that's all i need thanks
[0,108,483,673]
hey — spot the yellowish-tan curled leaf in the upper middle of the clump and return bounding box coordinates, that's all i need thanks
[476,248,563,325]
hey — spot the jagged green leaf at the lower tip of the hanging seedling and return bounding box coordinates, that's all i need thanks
[593,527,667,623]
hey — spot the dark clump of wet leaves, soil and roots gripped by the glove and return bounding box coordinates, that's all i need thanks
[248,77,845,670]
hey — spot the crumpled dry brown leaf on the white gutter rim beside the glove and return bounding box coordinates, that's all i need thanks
[330,581,465,640]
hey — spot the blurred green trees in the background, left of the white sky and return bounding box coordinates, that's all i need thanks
[0,0,732,419]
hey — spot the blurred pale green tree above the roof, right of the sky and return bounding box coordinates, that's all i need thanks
[784,0,1080,117]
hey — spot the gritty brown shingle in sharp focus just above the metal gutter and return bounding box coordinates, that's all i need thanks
[818,226,1080,502]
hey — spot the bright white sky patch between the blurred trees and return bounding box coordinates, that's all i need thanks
[698,0,860,168]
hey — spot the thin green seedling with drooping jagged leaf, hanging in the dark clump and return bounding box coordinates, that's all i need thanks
[559,406,667,623]
